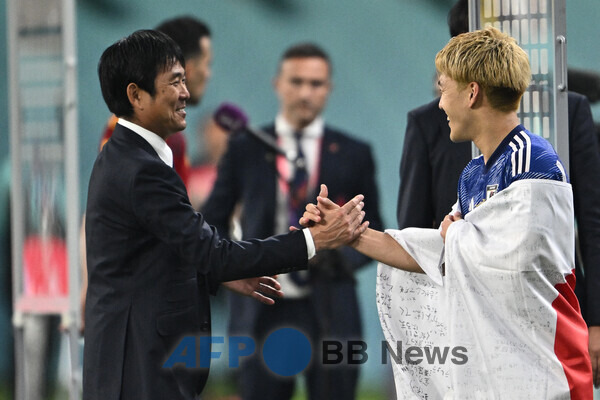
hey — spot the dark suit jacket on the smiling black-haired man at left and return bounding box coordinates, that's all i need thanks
[83,125,307,400]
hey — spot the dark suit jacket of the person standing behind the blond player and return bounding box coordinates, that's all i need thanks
[397,92,600,325]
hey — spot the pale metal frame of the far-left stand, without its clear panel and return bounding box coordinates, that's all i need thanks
[6,0,81,400]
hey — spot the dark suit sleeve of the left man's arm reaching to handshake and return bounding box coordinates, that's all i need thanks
[130,163,308,287]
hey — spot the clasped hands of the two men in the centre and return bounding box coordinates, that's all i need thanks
[302,185,369,251]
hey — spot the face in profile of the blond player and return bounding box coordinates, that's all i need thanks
[438,74,471,142]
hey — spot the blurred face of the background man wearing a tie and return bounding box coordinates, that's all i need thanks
[274,57,331,129]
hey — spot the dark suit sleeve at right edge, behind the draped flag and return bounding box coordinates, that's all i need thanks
[569,96,600,326]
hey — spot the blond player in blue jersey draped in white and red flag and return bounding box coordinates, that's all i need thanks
[301,28,592,399]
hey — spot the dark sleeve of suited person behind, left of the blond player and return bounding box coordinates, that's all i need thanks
[396,112,435,229]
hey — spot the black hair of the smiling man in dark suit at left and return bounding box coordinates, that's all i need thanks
[98,30,185,117]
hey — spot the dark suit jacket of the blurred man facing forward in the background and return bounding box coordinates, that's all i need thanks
[203,125,381,337]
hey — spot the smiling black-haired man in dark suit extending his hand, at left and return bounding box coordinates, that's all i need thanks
[83,30,366,400]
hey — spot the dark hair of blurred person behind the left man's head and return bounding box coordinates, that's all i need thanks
[156,16,210,59]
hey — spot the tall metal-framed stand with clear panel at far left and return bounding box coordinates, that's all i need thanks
[6,0,81,400]
